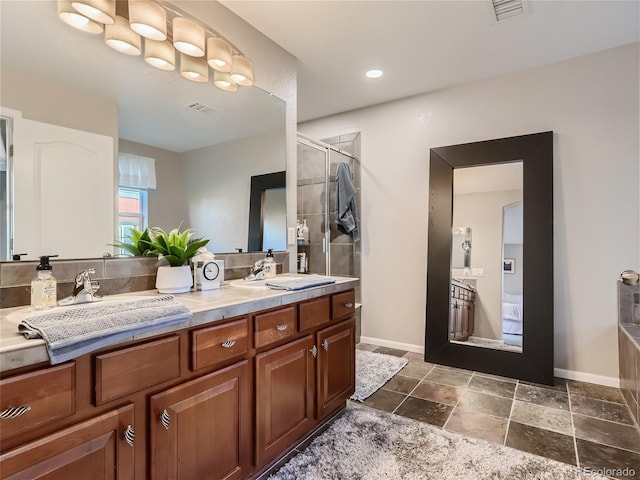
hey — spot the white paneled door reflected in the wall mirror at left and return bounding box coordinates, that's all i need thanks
[13,119,115,259]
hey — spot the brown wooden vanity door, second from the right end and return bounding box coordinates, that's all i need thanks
[255,335,315,468]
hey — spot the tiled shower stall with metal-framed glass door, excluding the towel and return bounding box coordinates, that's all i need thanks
[297,133,362,280]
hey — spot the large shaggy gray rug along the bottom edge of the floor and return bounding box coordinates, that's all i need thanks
[269,404,604,480]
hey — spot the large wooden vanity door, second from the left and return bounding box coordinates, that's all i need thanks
[150,360,251,480]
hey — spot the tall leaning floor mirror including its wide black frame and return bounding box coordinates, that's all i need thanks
[425,132,553,384]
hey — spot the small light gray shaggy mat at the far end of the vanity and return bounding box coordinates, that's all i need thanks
[351,349,409,402]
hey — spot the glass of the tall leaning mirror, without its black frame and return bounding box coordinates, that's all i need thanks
[449,162,523,353]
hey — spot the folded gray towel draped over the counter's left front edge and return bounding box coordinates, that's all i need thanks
[18,295,192,365]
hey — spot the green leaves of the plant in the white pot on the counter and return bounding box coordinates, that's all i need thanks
[149,227,209,267]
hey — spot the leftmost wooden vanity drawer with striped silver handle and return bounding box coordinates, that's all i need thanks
[0,363,76,438]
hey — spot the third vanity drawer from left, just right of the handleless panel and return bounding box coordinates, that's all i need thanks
[191,318,249,370]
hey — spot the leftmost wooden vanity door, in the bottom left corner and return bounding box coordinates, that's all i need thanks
[0,405,134,480]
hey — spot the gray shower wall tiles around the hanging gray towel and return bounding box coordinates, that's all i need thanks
[298,132,362,288]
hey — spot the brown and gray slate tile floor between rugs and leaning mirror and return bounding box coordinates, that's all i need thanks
[358,344,640,480]
